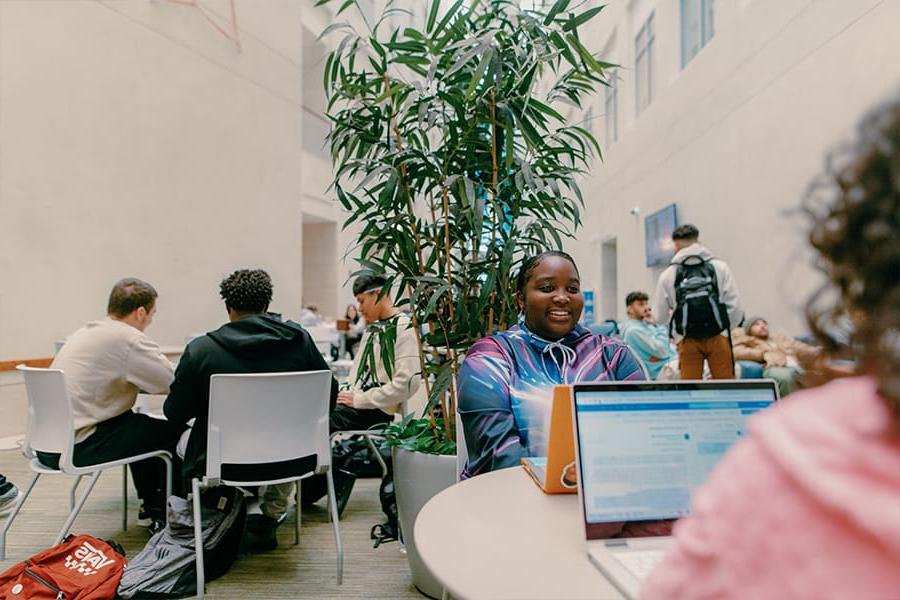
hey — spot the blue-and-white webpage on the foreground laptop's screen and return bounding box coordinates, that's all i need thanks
[577,389,774,523]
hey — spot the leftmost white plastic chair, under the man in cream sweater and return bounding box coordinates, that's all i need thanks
[0,365,172,560]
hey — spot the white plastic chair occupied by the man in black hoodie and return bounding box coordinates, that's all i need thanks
[191,371,344,598]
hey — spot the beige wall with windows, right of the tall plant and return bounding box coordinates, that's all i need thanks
[571,0,900,333]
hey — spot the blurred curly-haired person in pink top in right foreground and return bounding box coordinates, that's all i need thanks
[642,97,900,600]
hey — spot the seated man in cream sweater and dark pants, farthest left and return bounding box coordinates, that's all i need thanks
[38,278,184,526]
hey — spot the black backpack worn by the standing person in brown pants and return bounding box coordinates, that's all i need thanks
[669,254,730,339]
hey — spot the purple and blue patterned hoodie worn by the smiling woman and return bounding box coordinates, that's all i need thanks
[459,324,644,478]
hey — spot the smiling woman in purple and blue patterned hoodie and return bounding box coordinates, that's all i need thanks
[459,251,644,478]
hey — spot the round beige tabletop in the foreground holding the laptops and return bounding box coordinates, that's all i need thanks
[414,467,622,600]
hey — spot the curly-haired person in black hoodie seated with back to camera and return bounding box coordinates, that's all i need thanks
[163,269,340,550]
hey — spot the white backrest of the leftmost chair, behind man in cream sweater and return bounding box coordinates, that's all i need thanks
[16,365,75,470]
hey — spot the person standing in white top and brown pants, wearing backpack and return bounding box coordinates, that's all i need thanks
[653,225,744,379]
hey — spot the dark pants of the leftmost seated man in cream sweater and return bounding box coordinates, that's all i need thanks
[37,411,184,514]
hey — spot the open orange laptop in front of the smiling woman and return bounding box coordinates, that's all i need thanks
[522,385,578,494]
